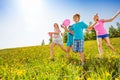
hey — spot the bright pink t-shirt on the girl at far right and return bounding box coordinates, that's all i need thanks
[94,19,107,35]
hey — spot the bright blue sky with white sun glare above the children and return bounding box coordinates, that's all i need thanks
[0,0,120,49]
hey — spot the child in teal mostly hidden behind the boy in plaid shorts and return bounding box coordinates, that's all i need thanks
[61,25,73,58]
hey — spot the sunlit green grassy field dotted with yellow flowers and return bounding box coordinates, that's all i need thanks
[0,38,120,80]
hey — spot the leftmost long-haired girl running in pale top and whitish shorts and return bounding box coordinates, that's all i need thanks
[49,23,66,59]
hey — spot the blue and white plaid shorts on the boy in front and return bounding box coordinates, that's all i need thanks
[73,40,84,52]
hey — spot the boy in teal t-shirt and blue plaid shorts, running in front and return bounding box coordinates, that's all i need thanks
[64,14,88,65]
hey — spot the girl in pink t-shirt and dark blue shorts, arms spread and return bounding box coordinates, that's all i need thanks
[88,11,120,56]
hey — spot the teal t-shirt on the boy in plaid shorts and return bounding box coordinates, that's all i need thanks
[72,21,88,40]
